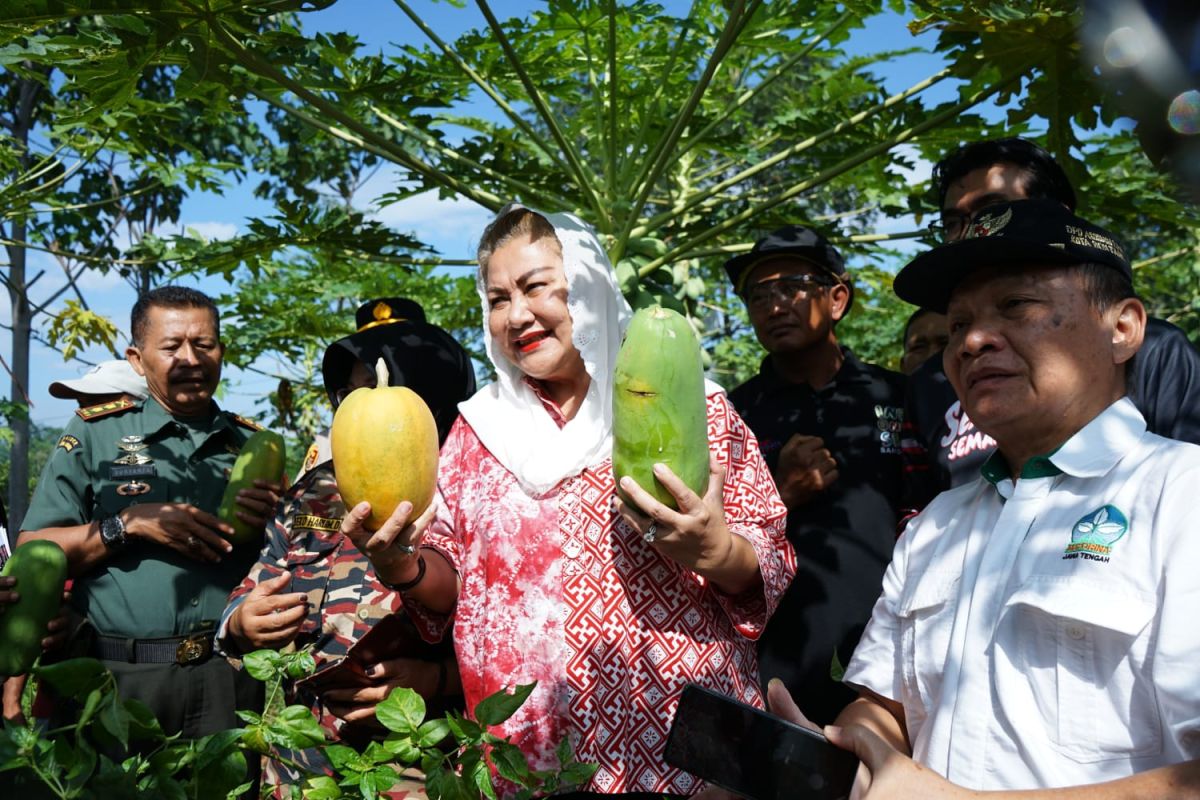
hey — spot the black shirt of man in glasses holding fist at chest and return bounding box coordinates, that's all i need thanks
[730,348,905,723]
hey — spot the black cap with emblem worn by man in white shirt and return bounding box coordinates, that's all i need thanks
[893,199,1133,313]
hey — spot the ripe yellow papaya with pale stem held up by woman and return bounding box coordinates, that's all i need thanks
[329,359,438,530]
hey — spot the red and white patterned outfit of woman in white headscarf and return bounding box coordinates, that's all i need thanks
[410,393,796,794]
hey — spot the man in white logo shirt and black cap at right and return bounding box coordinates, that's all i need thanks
[772,200,1200,798]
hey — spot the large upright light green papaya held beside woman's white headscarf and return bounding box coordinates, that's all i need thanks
[612,306,708,509]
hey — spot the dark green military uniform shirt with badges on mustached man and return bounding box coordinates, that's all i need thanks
[23,398,265,638]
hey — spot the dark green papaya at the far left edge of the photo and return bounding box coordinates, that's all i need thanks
[0,539,67,676]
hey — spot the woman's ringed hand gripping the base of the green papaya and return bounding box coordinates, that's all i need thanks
[616,455,761,594]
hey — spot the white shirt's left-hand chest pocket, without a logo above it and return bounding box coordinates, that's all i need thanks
[896,570,960,714]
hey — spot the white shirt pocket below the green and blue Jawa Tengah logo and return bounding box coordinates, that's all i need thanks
[1008,578,1163,763]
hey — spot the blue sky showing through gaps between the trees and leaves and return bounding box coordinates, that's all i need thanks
[0,0,954,426]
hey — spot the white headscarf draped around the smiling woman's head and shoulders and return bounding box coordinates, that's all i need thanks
[458,205,632,497]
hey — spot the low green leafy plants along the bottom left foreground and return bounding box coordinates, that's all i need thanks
[0,650,595,800]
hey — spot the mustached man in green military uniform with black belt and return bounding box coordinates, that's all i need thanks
[20,287,282,738]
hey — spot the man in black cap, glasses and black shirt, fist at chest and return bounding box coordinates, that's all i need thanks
[725,225,904,721]
